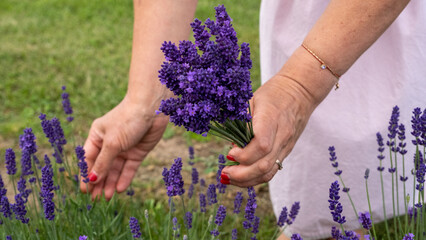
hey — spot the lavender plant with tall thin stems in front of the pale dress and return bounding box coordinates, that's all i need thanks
[329,106,426,240]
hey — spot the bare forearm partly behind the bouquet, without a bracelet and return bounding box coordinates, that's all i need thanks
[127,0,197,111]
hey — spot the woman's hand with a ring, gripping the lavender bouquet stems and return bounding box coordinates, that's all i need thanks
[222,75,315,187]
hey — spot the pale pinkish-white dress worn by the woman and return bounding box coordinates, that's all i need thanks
[260,0,426,240]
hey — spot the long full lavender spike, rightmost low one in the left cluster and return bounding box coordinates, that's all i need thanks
[40,159,55,221]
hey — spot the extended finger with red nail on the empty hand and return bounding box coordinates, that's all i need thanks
[89,134,121,184]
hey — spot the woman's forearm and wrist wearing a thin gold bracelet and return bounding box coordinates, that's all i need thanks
[280,0,409,104]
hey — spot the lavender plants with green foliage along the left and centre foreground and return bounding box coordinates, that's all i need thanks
[0,85,299,240]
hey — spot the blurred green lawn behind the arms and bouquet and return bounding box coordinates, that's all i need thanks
[0,0,260,142]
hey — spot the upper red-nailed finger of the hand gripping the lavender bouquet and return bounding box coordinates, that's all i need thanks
[227,106,277,165]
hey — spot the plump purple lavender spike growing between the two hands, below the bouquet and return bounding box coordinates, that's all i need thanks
[163,158,185,197]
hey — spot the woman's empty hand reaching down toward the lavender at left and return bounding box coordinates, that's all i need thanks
[80,98,168,199]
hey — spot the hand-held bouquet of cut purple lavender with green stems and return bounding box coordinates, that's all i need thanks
[158,5,254,164]
